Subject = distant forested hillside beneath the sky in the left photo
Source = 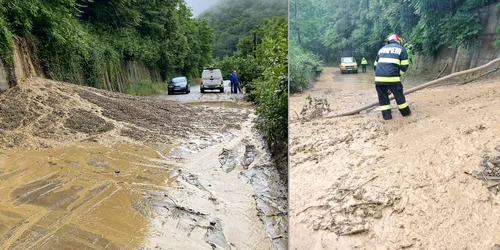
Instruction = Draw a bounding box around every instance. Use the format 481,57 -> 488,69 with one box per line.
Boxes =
199,0 -> 288,59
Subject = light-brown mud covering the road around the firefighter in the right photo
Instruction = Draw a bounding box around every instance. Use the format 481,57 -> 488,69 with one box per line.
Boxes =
289,68 -> 500,250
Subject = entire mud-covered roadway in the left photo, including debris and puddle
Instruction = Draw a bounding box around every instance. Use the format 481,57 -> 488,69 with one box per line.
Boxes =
0,78 -> 287,249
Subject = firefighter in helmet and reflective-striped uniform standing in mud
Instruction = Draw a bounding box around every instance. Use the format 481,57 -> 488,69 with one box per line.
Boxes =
373,34 -> 411,120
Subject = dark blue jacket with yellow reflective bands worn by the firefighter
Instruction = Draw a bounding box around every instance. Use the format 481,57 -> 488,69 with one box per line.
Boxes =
373,42 -> 409,85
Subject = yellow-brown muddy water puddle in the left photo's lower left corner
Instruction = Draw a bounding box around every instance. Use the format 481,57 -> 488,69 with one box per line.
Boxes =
0,144 -> 176,249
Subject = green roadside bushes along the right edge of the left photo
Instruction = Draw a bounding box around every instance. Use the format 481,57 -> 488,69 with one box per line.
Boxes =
215,16 -> 288,164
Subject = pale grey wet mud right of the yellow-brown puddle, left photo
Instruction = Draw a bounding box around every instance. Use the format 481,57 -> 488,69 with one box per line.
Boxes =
145,113 -> 288,250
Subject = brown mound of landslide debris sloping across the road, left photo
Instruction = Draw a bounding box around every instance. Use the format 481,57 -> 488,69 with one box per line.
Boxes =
0,78 -> 248,149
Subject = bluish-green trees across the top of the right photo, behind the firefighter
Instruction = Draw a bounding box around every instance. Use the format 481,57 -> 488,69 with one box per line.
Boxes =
290,0 -> 496,64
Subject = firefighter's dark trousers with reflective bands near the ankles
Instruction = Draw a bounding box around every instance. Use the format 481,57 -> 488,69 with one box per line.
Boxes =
375,82 -> 411,120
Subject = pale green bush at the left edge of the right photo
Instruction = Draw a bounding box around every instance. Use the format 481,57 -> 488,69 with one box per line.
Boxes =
290,41 -> 323,93
